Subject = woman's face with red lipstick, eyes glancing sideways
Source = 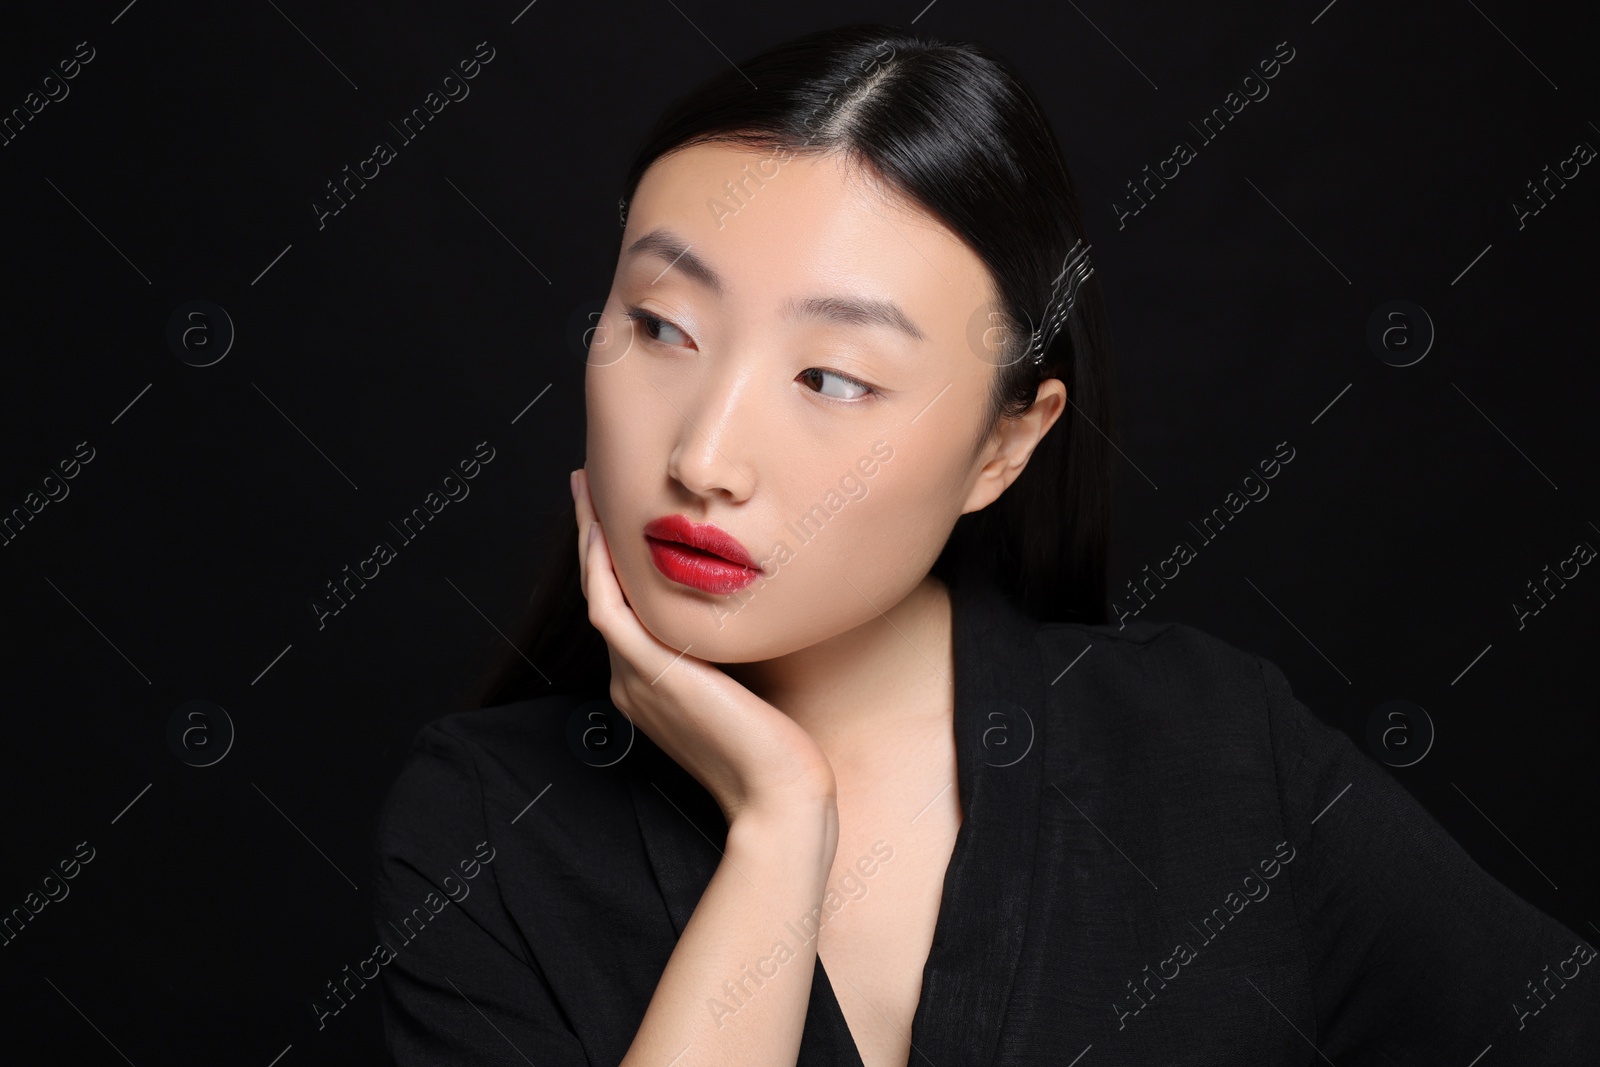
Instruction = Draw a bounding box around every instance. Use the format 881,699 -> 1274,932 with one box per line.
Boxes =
584,144 -> 1061,662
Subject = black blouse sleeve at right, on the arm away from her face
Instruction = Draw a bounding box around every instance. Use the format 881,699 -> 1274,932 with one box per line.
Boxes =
1258,659 -> 1600,1067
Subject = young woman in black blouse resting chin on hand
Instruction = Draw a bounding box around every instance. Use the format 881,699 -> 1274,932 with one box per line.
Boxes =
368,26 -> 1600,1067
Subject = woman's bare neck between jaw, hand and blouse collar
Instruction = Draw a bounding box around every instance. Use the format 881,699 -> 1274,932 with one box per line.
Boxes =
718,574 -> 955,769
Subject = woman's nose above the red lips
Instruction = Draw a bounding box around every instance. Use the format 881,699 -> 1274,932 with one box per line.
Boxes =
658,350 -> 762,502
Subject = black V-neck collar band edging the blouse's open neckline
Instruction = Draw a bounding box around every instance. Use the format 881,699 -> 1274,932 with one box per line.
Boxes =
629,563 -> 1045,1067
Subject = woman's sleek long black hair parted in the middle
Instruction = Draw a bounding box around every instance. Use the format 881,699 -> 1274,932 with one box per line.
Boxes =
470,24 -> 1117,707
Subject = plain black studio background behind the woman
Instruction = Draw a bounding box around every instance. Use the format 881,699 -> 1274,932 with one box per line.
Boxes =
0,0 -> 1600,1067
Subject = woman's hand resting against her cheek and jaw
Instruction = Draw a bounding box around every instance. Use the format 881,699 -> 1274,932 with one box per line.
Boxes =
573,467 -> 837,827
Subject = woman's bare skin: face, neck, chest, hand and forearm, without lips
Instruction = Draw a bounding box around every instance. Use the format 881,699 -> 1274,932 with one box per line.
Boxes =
573,144 -> 1066,1067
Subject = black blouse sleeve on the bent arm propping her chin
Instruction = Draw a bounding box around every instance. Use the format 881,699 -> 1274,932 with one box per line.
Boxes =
373,721 -> 589,1067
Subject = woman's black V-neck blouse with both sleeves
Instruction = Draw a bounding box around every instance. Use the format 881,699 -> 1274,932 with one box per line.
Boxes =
368,566 -> 1600,1067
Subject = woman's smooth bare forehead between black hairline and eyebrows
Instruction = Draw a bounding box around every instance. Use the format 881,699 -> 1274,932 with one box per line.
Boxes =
622,144 -> 990,313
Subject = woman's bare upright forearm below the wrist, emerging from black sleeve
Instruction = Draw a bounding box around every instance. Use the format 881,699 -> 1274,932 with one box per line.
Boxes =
622,800 -> 838,1067
